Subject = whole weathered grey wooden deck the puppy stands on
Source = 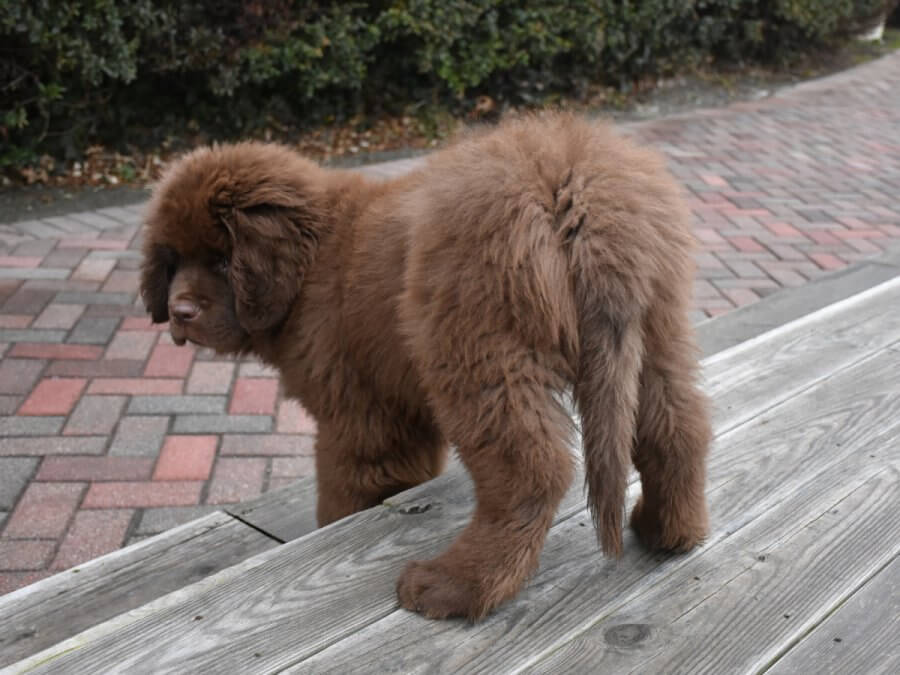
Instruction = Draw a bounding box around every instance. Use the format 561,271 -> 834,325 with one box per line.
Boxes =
0,277 -> 900,674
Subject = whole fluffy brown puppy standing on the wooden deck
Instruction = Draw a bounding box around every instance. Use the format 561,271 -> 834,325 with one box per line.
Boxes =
142,114 -> 710,619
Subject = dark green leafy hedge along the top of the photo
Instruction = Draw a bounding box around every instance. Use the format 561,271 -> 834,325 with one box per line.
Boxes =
0,0 -> 895,167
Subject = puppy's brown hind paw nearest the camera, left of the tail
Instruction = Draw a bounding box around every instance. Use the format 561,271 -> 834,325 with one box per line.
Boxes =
397,559 -> 490,621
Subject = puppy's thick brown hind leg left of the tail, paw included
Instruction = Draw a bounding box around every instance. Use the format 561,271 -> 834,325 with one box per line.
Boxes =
397,332 -> 573,620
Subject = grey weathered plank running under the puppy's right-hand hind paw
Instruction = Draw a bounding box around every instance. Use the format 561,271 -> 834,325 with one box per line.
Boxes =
286,350 -> 900,673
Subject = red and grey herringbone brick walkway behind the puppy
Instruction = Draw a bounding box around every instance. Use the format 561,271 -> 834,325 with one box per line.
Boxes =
0,52 -> 900,593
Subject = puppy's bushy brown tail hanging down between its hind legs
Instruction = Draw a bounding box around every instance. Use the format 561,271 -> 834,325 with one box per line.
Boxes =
573,251 -> 643,557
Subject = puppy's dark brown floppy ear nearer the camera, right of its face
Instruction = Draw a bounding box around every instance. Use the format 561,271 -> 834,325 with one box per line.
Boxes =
222,203 -> 318,333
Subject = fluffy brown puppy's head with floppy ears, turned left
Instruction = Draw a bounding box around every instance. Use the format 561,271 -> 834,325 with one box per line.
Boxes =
141,143 -> 324,353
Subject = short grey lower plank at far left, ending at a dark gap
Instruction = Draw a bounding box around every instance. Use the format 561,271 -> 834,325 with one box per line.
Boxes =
0,512 -> 278,666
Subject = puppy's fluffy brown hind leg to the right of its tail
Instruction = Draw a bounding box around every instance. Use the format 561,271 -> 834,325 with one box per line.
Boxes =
631,298 -> 711,551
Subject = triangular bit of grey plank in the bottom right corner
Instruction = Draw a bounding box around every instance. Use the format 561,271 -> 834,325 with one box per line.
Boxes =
766,558 -> 900,675
